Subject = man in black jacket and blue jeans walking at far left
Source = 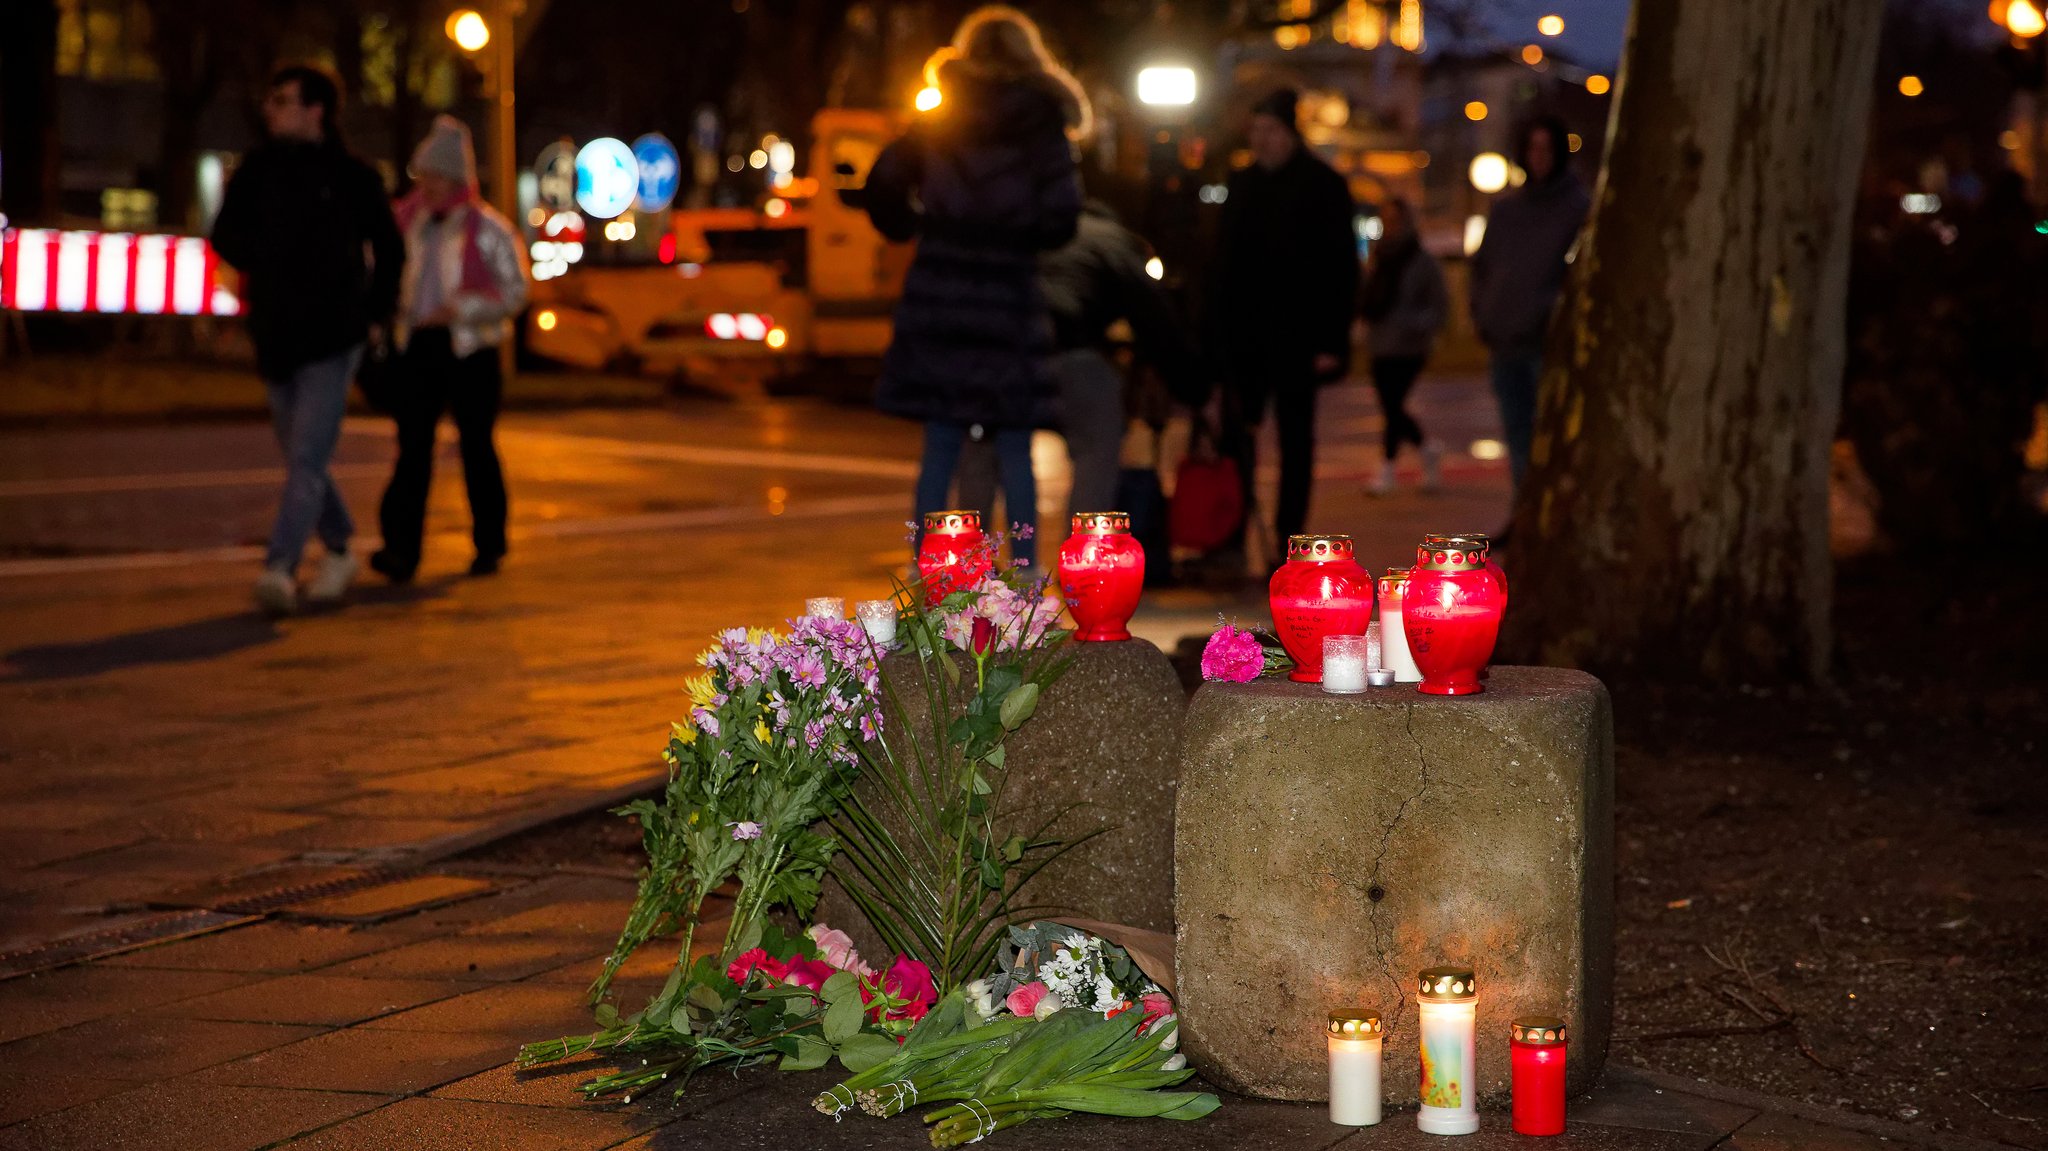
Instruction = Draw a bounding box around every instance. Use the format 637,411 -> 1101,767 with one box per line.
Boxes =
213,66 -> 406,614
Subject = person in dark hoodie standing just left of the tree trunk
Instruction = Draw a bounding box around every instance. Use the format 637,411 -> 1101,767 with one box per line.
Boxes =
1470,117 -> 1591,497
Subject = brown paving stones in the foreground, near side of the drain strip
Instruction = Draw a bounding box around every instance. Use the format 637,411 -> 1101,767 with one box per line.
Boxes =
0,862 -> 1989,1151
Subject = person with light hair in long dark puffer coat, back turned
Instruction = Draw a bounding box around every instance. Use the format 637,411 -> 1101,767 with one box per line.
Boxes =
864,4 -> 1090,565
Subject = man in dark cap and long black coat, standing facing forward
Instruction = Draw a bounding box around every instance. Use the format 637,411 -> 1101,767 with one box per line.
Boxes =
1208,88 -> 1358,559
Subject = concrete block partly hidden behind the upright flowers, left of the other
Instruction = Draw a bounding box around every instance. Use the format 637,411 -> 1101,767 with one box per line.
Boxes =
817,639 -> 1188,956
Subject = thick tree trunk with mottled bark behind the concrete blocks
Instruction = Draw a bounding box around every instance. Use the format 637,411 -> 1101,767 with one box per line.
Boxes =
1503,0 -> 1884,682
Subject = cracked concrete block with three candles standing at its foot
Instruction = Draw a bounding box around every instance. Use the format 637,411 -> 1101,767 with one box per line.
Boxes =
1174,668 -> 1614,1104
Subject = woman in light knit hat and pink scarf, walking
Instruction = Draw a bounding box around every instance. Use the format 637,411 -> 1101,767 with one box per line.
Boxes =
371,117 -> 526,584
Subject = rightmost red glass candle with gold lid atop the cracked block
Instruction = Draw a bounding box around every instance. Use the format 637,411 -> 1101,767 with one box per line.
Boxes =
1401,541 -> 1501,696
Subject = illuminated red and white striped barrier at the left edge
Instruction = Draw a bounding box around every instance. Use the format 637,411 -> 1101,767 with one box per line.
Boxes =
0,227 -> 242,315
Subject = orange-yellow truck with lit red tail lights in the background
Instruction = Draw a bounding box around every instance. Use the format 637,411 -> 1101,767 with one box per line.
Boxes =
524,109 -> 909,389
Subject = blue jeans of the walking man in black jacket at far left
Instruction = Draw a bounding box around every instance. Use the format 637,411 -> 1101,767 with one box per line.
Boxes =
262,344 -> 362,571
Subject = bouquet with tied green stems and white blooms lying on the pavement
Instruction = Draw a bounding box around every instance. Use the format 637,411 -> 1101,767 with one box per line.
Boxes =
813,924 -> 1219,1147
